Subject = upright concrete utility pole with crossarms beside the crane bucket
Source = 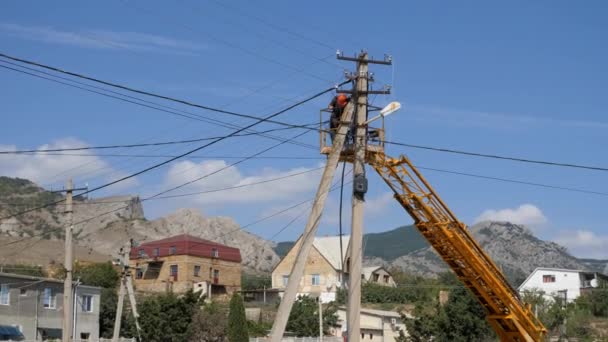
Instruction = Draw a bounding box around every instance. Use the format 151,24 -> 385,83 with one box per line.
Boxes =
346,52 -> 368,342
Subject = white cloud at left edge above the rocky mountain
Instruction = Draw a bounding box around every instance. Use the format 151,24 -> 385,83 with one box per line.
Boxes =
0,138 -> 137,190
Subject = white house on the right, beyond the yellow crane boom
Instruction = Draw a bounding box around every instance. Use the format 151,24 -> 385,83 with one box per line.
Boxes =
518,267 -> 608,302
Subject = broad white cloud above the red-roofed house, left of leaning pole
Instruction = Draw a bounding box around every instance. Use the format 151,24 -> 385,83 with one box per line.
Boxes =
165,160 -> 321,205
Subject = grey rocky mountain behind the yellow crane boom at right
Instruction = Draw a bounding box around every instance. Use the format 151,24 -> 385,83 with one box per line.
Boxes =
277,222 -> 608,285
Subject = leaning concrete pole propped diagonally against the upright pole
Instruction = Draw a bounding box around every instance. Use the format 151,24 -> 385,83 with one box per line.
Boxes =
270,103 -> 354,342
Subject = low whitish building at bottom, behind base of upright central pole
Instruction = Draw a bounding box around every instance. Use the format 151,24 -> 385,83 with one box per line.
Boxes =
332,308 -> 408,342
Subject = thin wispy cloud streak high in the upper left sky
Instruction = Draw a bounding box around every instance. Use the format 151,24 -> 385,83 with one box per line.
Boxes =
0,23 -> 204,54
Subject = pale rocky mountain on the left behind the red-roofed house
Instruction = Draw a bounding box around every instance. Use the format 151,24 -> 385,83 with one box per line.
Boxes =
0,177 -> 279,272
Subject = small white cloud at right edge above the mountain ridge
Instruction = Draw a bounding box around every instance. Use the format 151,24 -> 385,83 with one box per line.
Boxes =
554,229 -> 608,259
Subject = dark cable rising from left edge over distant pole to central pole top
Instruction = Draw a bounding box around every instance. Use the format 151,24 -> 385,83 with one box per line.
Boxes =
0,81 -> 334,220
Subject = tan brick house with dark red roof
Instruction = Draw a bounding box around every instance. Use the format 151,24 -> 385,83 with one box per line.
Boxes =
129,234 -> 241,296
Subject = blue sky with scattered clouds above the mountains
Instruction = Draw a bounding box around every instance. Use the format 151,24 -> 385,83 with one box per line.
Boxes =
0,0 -> 608,258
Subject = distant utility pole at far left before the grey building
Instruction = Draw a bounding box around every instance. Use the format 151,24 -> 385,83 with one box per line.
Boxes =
61,178 -> 74,342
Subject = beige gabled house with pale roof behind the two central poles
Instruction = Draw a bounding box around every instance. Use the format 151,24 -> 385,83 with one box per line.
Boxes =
272,235 -> 395,303
